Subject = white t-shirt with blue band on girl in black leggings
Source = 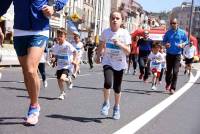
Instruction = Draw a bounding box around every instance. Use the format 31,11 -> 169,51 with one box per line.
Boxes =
100,28 -> 131,71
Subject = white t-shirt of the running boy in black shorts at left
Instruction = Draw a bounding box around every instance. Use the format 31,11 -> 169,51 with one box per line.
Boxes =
52,41 -> 76,71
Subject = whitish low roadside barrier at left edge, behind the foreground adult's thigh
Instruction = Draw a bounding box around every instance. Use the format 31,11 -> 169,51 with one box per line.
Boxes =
0,44 -> 19,66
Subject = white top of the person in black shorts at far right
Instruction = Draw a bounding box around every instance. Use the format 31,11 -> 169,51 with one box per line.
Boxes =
183,45 -> 196,59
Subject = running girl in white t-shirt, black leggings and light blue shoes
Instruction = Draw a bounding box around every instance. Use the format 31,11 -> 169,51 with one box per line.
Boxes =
96,11 -> 131,120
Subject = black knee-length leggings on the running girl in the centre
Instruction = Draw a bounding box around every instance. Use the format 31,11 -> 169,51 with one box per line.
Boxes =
103,65 -> 123,94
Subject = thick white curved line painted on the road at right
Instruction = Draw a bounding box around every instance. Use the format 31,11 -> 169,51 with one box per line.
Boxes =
114,70 -> 200,134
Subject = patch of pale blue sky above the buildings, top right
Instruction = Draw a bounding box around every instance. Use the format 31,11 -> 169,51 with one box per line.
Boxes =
135,0 -> 200,12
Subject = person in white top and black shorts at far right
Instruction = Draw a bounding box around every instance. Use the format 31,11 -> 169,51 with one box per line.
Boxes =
183,42 -> 196,75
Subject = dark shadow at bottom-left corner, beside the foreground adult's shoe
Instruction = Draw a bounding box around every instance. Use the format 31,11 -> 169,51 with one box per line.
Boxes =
0,117 -> 25,125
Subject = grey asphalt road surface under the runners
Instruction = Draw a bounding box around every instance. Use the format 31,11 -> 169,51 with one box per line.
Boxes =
0,65 -> 200,134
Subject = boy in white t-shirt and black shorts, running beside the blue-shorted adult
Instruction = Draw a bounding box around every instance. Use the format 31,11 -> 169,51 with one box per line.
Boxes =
52,28 -> 77,100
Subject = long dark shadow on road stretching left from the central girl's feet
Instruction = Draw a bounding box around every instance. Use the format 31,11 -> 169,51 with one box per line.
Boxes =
46,114 -> 111,123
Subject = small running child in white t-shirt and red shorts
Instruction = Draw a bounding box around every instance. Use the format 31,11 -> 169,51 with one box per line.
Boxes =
148,42 -> 164,90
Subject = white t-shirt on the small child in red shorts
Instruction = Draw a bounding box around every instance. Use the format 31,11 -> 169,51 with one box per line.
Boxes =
148,52 -> 164,72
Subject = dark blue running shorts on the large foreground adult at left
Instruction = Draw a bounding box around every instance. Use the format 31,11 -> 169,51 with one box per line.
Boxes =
13,35 -> 48,56
